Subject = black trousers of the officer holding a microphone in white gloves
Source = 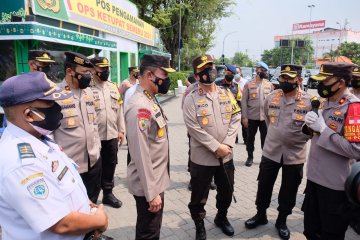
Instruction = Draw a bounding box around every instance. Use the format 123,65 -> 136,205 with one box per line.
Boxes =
302,180 -> 349,240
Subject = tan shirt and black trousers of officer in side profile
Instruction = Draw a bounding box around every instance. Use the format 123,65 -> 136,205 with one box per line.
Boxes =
124,85 -> 170,239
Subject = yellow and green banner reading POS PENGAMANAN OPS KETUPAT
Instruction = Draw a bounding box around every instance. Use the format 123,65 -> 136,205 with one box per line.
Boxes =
32,0 -> 157,46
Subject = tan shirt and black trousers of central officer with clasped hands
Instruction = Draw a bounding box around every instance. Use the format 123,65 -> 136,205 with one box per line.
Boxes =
183,86 -> 241,221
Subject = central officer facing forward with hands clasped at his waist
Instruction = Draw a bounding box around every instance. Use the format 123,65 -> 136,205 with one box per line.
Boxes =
183,54 -> 241,239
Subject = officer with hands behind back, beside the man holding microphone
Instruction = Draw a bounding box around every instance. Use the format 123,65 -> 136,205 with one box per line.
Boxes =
245,64 -> 311,239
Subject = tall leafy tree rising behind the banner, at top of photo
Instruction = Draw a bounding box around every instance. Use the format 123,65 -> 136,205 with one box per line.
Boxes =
133,0 -> 234,66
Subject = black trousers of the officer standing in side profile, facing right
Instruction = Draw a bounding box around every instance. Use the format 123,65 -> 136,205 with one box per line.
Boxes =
134,193 -> 164,240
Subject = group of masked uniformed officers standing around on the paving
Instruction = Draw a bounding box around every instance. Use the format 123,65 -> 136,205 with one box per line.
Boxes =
0,47 -> 360,239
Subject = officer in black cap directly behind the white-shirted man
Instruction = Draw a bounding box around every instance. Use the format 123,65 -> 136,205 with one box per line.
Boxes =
53,52 -> 101,203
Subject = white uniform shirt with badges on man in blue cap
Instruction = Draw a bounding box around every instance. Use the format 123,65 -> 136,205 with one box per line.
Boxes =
0,122 -> 90,240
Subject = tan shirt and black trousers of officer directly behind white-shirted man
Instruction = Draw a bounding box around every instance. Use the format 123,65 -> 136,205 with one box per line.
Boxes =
53,80 -> 101,202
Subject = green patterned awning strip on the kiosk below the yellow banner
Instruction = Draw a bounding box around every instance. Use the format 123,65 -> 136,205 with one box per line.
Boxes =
0,22 -> 117,51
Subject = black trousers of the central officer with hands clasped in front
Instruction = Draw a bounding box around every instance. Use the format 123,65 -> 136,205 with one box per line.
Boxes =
188,160 -> 235,221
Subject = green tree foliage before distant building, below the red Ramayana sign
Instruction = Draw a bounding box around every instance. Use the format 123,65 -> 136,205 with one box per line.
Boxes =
261,40 -> 314,67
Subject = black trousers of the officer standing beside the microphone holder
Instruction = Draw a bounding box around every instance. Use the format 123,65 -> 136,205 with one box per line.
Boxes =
256,156 -> 304,218
